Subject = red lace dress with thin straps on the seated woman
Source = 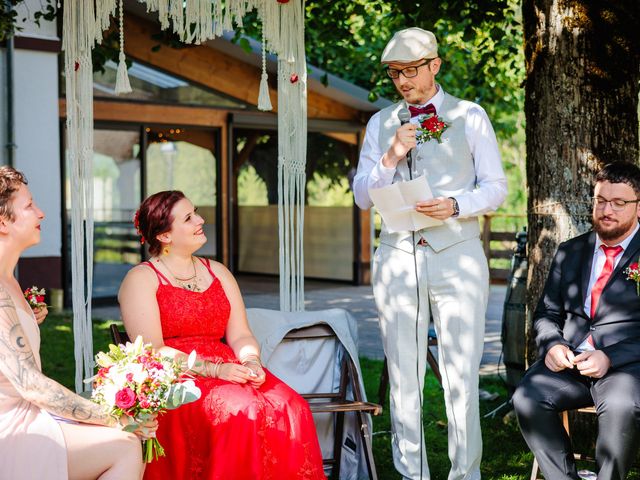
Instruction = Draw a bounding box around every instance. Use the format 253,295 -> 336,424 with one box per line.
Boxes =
144,262 -> 325,480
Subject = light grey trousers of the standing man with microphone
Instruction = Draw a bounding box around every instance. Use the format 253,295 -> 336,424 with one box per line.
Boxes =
373,238 -> 489,480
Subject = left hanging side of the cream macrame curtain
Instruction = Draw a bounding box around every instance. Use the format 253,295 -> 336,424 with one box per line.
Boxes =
62,0 -> 102,392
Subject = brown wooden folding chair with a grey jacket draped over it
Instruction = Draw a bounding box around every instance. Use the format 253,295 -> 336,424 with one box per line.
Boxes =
282,323 -> 382,480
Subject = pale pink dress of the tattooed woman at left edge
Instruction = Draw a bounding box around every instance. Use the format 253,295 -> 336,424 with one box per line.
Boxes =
0,308 -> 68,480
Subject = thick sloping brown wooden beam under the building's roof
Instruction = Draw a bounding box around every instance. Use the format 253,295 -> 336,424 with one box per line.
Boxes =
119,15 -> 360,121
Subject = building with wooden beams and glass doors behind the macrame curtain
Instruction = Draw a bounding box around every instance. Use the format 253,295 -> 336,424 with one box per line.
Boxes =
0,2 -> 388,301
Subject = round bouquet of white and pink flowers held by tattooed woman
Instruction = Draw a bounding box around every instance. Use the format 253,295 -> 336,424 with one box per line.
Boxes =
86,336 -> 200,463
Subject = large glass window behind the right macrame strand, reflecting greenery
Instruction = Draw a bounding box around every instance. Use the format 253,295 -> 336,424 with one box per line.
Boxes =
233,128 -> 357,281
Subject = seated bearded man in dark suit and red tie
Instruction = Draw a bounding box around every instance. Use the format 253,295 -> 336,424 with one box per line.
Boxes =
513,162 -> 640,480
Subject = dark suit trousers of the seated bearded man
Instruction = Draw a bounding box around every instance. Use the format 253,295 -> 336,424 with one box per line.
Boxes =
513,360 -> 640,480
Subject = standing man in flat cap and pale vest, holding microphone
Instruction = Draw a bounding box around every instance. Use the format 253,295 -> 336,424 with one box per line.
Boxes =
353,28 -> 507,480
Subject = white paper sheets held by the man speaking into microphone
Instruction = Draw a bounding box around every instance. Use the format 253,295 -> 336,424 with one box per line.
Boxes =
369,176 -> 442,233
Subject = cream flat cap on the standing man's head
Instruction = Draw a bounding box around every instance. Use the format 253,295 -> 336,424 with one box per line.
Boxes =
380,27 -> 438,63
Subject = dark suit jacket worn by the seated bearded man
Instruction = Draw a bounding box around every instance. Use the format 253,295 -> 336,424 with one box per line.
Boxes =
534,230 -> 640,368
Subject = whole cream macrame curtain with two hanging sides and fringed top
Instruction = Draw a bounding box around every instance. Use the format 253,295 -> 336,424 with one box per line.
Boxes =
62,0 -> 307,391
